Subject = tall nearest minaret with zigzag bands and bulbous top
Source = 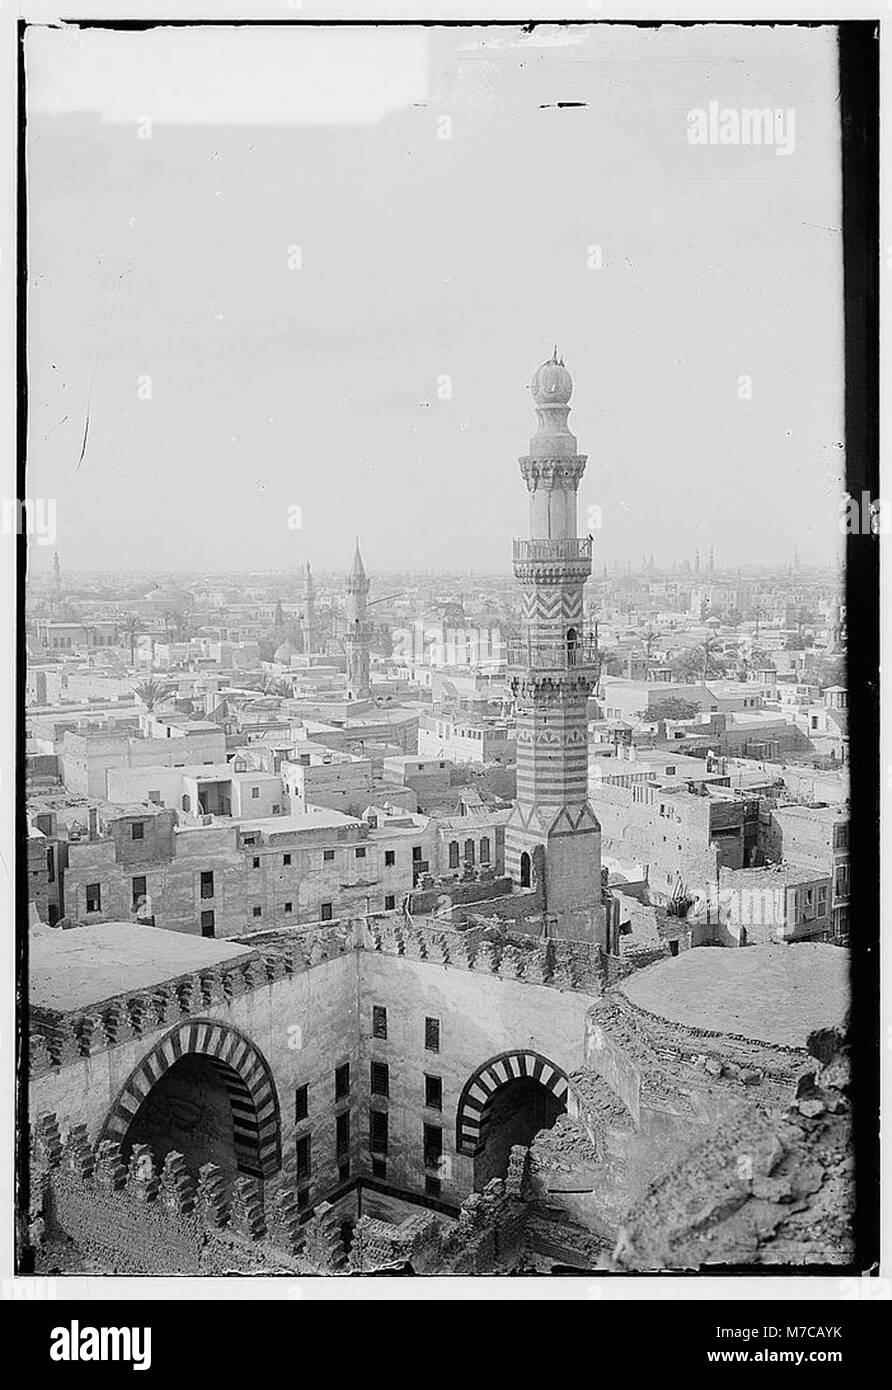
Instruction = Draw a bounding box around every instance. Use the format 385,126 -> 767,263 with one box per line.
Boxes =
504,349 -> 606,945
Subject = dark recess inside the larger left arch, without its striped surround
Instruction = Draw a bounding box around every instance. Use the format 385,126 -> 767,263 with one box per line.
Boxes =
121,1054 -> 239,1177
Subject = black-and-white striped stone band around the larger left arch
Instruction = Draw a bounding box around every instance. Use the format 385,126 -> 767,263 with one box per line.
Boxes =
103,1019 -> 282,1177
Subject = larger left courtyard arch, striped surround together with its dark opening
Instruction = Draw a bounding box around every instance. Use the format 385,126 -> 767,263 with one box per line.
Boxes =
103,1019 -> 282,1177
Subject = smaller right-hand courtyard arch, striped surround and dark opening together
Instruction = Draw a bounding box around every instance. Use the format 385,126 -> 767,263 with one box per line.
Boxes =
456,1051 -> 567,1191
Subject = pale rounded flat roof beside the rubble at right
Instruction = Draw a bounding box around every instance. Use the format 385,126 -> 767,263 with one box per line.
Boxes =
618,941 -> 849,1049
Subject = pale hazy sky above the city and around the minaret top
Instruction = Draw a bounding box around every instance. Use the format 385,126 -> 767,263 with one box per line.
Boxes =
26,25 -> 845,571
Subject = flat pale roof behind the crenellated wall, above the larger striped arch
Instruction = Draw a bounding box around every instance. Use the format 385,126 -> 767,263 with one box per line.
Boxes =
28,922 -> 253,1013
